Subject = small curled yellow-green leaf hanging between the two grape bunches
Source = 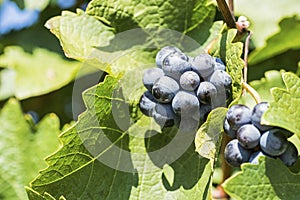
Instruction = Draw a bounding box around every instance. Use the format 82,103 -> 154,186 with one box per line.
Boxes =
195,107 -> 227,160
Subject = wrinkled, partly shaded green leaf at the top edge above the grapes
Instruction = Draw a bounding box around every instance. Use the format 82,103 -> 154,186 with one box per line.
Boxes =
86,0 -> 215,43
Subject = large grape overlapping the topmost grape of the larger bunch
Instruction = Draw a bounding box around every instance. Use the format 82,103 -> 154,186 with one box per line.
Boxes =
162,53 -> 192,81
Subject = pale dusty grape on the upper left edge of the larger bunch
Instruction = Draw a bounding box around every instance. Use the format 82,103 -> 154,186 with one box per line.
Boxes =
142,67 -> 164,91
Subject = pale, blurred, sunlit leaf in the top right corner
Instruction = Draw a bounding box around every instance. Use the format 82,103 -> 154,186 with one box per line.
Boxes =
234,0 -> 300,48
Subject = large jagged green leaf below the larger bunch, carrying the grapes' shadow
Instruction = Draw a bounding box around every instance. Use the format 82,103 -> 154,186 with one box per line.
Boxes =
27,76 -> 212,199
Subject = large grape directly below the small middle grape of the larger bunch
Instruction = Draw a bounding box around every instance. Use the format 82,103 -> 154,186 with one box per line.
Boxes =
172,91 -> 200,119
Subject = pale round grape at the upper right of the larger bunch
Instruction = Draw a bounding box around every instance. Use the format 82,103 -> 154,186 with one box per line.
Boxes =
190,53 -> 215,78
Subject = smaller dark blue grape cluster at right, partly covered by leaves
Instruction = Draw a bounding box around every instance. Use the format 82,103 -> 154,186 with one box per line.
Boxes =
224,102 -> 298,167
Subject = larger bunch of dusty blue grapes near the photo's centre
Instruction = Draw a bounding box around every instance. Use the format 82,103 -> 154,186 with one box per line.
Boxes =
139,46 -> 232,131
